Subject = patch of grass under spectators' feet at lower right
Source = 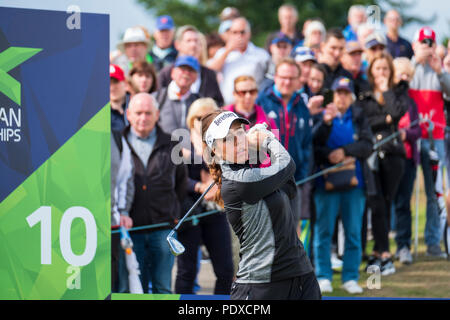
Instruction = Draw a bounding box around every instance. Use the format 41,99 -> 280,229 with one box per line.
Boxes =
324,172 -> 450,298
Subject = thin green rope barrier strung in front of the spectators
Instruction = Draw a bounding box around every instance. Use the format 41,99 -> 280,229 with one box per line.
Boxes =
111,119 -> 450,233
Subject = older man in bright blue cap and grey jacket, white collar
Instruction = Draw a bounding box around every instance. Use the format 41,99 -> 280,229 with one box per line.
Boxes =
155,56 -> 200,149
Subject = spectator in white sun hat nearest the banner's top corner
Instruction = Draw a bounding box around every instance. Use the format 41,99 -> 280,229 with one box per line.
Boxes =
111,26 -> 153,74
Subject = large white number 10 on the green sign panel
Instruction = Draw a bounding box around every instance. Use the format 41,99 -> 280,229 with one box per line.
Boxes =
26,206 -> 97,267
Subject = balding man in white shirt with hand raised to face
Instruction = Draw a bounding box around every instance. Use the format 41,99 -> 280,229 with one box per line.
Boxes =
208,17 -> 270,104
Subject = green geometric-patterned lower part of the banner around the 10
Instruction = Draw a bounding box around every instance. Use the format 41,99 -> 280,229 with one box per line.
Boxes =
0,103 -> 111,299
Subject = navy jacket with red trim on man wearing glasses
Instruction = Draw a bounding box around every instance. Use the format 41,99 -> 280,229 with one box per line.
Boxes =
256,86 -> 312,181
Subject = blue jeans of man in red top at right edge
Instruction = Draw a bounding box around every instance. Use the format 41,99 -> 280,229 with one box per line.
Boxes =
420,139 -> 445,246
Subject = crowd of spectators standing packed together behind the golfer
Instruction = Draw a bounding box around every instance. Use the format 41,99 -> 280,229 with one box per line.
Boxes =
110,5 -> 450,294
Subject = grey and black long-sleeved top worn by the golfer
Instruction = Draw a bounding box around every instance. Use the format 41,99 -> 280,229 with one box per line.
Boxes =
221,138 -> 313,283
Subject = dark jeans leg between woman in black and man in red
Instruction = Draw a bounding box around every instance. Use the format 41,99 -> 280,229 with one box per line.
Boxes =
394,159 -> 417,251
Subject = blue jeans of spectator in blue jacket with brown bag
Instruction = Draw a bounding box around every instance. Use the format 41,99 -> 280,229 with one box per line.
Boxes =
313,188 -> 366,282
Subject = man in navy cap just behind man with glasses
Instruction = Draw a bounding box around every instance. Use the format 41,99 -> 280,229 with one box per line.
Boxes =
259,32 -> 292,91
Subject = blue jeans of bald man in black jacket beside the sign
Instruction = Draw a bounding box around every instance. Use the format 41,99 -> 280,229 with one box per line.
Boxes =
131,229 -> 175,294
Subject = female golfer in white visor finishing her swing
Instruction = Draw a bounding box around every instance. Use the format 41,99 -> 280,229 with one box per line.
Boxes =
202,111 -> 321,300
